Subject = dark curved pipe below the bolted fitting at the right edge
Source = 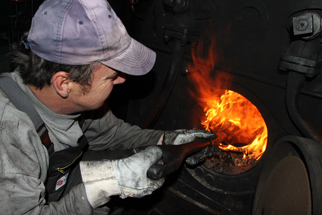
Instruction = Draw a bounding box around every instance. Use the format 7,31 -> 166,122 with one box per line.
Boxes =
286,72 -> 322,145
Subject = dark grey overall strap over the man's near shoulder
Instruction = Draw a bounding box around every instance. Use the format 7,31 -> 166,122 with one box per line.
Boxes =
0,76 -> 54,155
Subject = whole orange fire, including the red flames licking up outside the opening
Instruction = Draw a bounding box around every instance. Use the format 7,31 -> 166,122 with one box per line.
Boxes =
189,34 -> 268,163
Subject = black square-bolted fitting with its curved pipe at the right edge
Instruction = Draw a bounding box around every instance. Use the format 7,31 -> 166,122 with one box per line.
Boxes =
279,11 -> 322,144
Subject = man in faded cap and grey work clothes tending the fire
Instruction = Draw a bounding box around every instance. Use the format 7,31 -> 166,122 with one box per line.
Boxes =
0,0 -> 215,214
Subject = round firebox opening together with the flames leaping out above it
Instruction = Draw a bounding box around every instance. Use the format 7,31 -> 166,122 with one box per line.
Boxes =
188,26 -> 268,174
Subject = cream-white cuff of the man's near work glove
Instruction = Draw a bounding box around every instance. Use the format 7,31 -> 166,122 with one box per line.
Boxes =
80,160 -> 120,209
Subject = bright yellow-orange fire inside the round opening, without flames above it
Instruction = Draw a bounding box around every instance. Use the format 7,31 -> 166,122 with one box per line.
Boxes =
201,90 -> 267,159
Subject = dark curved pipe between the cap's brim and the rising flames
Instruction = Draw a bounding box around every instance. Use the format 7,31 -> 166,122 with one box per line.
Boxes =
141,40 -> 186,128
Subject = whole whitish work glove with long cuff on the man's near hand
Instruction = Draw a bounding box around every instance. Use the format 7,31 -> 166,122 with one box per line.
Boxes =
80,146 -> 164,209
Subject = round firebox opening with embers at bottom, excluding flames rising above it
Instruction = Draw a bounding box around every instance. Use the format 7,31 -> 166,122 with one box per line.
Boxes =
190,90 -> 268,175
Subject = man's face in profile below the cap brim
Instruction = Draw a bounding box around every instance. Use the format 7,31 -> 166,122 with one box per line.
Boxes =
70,65 -> 125,112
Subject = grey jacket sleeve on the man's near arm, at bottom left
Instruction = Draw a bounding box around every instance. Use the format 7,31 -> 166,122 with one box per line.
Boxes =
0,97 -> 93,214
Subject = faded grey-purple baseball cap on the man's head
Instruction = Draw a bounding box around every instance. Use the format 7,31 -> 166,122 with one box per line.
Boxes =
28,0 -> 156,75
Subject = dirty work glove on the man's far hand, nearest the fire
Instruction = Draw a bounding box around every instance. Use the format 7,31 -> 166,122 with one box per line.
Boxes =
162,129 -> 217,166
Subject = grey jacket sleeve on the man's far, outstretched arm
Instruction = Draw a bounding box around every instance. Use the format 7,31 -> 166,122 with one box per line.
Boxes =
83,105 -> 163,150
